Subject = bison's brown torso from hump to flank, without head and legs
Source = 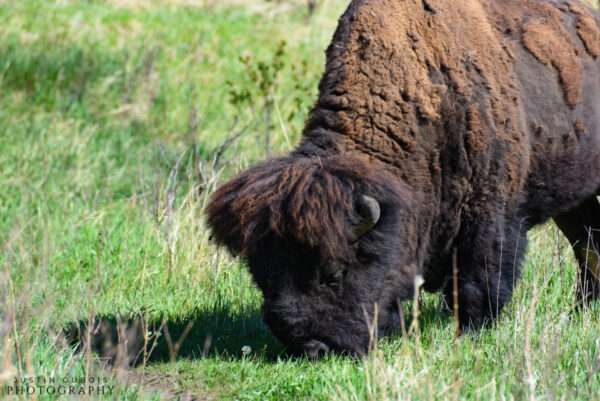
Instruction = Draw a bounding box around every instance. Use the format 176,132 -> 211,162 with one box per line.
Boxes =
296,0 -> 600,288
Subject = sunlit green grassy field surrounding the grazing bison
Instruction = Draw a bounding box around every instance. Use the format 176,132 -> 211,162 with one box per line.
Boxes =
0,0 -> 600,401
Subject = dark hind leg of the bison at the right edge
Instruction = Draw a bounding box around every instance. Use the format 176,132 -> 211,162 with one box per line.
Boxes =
554,196 -> 600,305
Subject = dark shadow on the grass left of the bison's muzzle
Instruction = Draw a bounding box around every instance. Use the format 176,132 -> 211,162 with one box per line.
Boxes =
65,308 -> 289,367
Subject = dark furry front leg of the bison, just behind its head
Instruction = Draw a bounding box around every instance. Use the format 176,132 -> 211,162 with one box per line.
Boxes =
444,214 -> 527,329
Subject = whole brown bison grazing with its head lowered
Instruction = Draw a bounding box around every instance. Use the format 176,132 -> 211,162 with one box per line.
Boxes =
207,0 -> 600,356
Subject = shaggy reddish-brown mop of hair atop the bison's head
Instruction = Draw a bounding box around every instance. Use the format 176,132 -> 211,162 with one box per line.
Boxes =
207,155 -> 401,260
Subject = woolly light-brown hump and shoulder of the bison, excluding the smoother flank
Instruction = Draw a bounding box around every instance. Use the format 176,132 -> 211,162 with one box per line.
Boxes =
297,0 -> 528,276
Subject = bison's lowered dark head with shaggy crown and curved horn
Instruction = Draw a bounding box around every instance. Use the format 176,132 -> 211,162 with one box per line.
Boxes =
208,156 -> 416,357
